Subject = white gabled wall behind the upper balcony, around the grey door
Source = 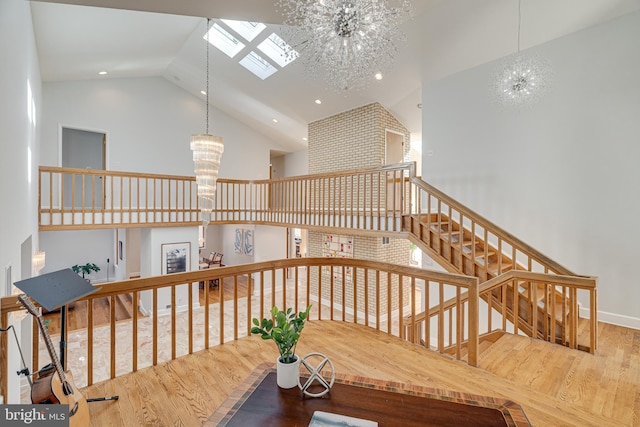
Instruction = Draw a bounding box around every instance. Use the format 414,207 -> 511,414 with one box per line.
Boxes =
41,77 -> 280,179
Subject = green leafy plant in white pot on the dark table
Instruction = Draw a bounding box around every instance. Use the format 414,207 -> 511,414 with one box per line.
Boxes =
251,306 -> 311,388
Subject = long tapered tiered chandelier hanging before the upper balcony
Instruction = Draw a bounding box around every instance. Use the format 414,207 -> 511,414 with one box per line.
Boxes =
191,19 -> 224,227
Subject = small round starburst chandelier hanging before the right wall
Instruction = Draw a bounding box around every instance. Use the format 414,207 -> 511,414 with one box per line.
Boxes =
495,0 -> 549,107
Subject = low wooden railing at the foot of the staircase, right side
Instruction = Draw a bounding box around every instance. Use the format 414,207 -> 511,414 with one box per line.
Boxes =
404,270 -> 598,359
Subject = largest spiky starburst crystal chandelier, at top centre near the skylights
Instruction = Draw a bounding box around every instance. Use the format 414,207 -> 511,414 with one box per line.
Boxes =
277,0 -> 411,91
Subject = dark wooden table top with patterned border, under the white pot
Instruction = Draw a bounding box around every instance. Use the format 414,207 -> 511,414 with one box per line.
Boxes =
203,364 -> 531,427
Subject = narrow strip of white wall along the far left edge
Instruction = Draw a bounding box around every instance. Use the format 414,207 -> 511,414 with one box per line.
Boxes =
0,0 -> 41,403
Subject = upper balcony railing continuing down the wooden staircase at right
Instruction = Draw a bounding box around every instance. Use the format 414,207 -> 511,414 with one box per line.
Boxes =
39,163 -> 597,368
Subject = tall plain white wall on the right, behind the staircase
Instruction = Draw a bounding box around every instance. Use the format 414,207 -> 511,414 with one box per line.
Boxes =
422,13 -> 640,327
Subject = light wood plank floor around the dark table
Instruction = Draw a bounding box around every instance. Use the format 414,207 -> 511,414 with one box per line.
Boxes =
83,320 -> 640,427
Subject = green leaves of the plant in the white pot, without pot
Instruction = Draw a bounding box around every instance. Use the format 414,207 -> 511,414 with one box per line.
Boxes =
251,306 -> 311,363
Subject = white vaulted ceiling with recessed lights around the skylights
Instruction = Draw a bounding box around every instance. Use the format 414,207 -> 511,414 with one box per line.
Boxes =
31,0 -> 640,152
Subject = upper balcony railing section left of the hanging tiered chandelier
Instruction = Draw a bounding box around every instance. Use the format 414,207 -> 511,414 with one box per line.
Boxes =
38,166 -> 199,231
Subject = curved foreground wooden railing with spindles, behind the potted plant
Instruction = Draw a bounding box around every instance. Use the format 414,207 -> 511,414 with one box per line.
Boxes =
0,258 -> 479,399
